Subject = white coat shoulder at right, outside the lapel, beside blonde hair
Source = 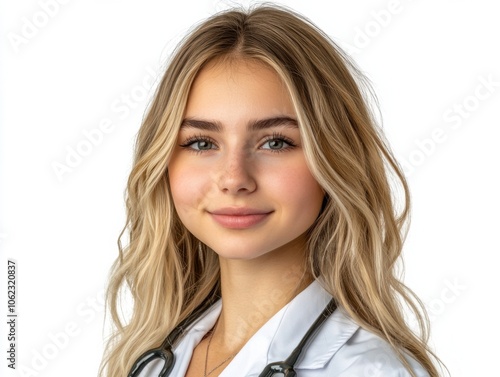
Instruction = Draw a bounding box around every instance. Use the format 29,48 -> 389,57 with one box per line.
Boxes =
330,320 -> 429,377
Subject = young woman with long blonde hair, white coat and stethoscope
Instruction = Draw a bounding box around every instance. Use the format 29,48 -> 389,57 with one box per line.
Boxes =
101,6 -> 444,377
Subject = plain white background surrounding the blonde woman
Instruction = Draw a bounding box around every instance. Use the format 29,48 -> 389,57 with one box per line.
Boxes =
0,0 -> 500,377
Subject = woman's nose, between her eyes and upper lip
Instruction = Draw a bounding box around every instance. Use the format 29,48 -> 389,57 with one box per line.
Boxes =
217,152 -> 257,195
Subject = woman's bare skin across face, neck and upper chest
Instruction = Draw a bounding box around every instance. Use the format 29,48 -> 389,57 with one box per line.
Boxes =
168,60 -> 324,377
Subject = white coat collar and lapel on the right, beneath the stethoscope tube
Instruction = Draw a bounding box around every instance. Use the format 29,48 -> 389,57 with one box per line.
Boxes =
220,281 -> 359,377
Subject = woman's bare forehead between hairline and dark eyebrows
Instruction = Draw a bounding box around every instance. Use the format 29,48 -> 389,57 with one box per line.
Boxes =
185,59 -> 295,121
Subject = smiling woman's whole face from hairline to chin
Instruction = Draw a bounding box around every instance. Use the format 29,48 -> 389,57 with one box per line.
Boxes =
168,60 -> 323,259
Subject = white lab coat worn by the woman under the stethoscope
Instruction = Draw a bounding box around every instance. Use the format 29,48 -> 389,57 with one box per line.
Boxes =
141,281 -> 429,377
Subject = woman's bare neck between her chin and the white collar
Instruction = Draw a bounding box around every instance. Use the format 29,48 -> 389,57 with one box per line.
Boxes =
214,238 -> 312,352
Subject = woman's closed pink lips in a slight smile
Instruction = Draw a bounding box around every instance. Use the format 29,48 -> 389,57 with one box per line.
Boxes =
208,207 -> 273,229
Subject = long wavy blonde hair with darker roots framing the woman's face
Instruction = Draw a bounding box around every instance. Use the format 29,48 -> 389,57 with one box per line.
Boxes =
100,5 -> 444,377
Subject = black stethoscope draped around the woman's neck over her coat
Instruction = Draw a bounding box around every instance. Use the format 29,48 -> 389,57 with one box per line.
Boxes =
128,299 -> 337,377
